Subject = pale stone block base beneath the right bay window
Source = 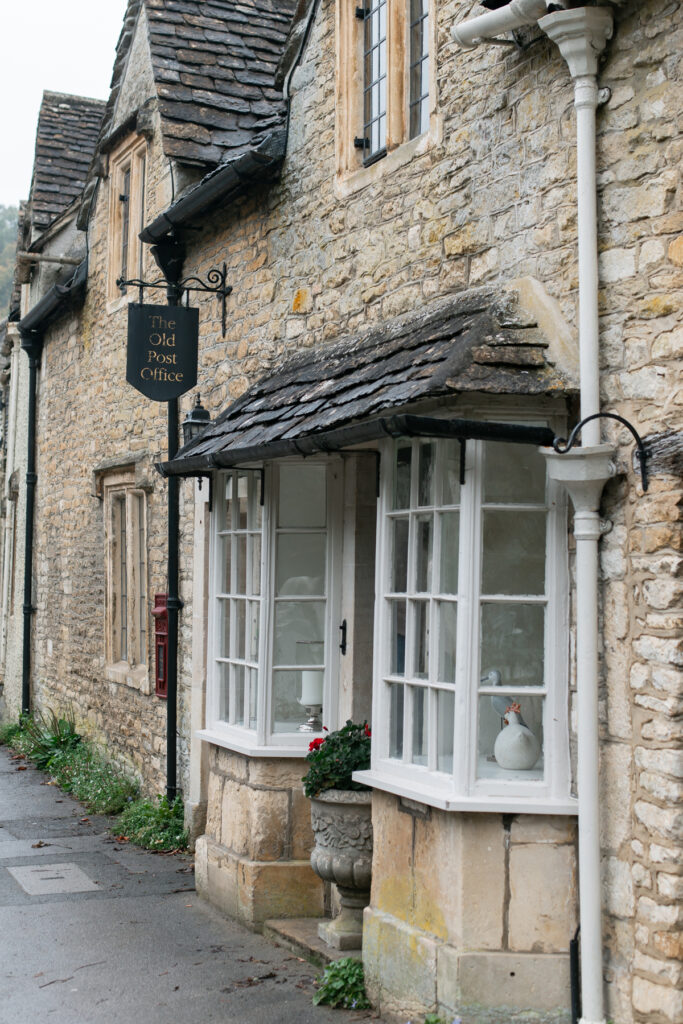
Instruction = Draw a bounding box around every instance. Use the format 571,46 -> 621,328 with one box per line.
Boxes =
362,793 -> 578,1024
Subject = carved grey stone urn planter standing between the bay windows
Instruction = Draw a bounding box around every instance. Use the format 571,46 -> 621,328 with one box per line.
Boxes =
310,790 -> 373,949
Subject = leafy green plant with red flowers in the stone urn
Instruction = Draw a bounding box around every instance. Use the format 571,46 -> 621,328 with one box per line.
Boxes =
301,720 -> 371,797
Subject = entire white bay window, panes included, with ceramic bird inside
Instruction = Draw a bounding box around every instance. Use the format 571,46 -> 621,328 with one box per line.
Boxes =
359,439 -> 573,813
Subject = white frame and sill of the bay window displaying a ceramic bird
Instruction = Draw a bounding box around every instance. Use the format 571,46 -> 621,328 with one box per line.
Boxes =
354,418 -> 577,814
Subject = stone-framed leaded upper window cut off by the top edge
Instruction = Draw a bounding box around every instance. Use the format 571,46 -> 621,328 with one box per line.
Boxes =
337,0 -> 435,186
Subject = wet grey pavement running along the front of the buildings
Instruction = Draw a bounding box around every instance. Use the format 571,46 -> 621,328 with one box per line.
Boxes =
0,748 -> 372,1024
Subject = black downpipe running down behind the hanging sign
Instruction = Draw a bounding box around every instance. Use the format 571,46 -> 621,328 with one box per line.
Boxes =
152,240 -> 184,803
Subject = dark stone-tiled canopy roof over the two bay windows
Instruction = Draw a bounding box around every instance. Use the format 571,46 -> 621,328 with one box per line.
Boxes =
158,289 -> 577,476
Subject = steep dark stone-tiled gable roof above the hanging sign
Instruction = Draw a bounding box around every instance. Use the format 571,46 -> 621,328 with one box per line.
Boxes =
102,0 -> 296,167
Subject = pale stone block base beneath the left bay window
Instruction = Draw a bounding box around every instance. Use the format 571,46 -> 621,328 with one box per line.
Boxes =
195,745 -> 325,929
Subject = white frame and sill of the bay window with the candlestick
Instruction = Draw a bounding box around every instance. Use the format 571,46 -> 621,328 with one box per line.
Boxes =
199,457 -> 343,758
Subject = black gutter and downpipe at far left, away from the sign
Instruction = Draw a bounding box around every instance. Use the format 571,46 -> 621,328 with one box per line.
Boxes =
17,259 -> 88,715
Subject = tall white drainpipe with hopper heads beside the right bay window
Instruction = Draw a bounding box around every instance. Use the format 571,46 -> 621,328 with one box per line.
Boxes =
452,8 -> 614,1024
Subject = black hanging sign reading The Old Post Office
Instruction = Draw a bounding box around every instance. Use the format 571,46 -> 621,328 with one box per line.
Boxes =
126,302 -> 199,401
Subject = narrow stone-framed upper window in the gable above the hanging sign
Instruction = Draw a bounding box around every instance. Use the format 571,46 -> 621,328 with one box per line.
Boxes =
109,136 -> 147,299
